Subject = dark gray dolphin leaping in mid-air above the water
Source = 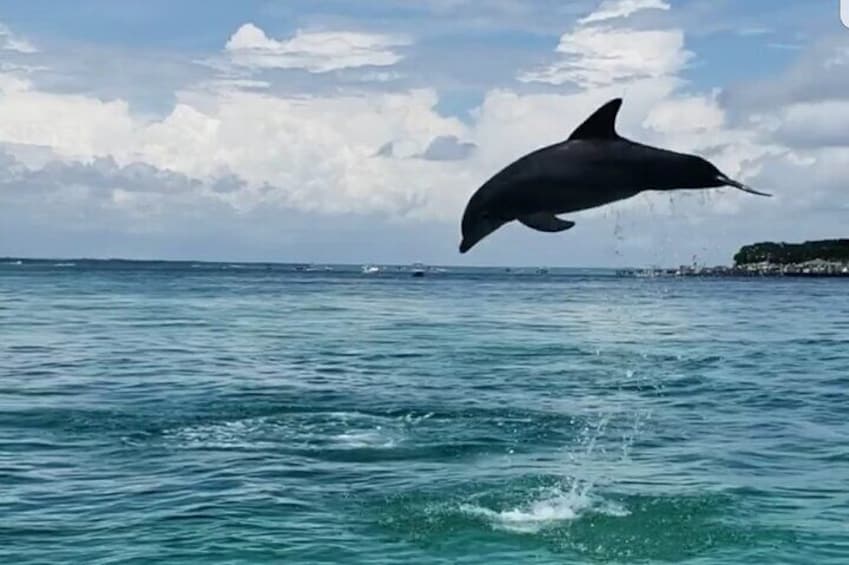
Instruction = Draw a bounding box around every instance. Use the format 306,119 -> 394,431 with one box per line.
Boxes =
460,98 -> 770,253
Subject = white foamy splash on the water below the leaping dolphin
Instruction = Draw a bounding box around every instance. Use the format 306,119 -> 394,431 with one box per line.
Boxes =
460,488 -> 630,534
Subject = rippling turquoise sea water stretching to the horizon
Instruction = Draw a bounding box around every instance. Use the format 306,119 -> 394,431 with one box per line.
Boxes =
0,261 -> 849,564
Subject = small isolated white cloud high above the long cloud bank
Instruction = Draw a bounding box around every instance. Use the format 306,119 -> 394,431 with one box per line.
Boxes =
225,23 -> 410,73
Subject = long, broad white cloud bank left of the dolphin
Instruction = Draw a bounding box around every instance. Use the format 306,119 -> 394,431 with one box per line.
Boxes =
0,72 -> 475,225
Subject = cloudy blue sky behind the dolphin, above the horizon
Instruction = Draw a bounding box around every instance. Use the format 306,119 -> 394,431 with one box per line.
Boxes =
0,0 -> 849,267
